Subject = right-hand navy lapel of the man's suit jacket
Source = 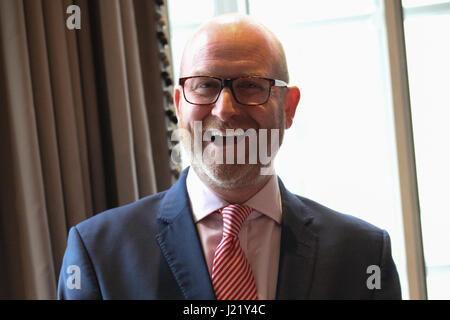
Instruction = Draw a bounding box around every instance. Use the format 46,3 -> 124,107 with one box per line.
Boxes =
276,180 -> 317,300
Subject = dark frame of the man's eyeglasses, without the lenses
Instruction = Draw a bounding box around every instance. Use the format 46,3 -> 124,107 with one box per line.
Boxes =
178,76 -> 288,106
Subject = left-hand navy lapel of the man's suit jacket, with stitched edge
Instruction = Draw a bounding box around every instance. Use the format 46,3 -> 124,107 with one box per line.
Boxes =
156,169 -> 216,299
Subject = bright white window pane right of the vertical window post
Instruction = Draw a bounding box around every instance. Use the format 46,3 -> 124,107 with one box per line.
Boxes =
403,0 -> 450,299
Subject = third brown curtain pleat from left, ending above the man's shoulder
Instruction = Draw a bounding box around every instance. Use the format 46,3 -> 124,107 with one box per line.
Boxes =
42,0 -> 88,225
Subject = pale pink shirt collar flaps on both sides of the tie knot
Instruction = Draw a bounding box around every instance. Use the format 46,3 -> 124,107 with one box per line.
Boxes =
186,168 -> 281,223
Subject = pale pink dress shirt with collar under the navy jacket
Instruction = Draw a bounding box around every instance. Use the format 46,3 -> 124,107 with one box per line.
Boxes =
186,168 -> 281,300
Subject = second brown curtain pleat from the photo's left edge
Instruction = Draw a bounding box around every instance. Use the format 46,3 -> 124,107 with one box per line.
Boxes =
24,0 -> 67,284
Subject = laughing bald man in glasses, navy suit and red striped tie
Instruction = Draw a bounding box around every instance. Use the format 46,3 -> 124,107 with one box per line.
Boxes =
58,15 -> 401,299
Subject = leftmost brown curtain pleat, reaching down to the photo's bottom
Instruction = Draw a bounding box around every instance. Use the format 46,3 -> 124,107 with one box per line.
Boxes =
0,0 -> 56,299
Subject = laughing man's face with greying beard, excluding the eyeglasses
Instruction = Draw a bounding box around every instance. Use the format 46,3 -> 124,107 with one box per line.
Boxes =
174,25 -> 296,189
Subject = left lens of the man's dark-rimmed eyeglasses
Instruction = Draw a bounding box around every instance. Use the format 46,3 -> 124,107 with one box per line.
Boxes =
184,77 -> 221,104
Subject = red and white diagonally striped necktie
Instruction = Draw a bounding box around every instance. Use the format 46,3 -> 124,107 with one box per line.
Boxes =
211,204 -> 258,300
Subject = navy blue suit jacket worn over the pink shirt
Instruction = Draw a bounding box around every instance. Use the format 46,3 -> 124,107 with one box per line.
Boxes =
58,170 -> 401,299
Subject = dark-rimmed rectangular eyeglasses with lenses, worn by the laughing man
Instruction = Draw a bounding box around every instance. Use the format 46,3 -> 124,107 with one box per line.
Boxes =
179,76 -> 288,106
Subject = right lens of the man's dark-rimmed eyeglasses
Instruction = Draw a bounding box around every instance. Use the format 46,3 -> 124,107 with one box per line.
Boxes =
233,77 -> 270,105
